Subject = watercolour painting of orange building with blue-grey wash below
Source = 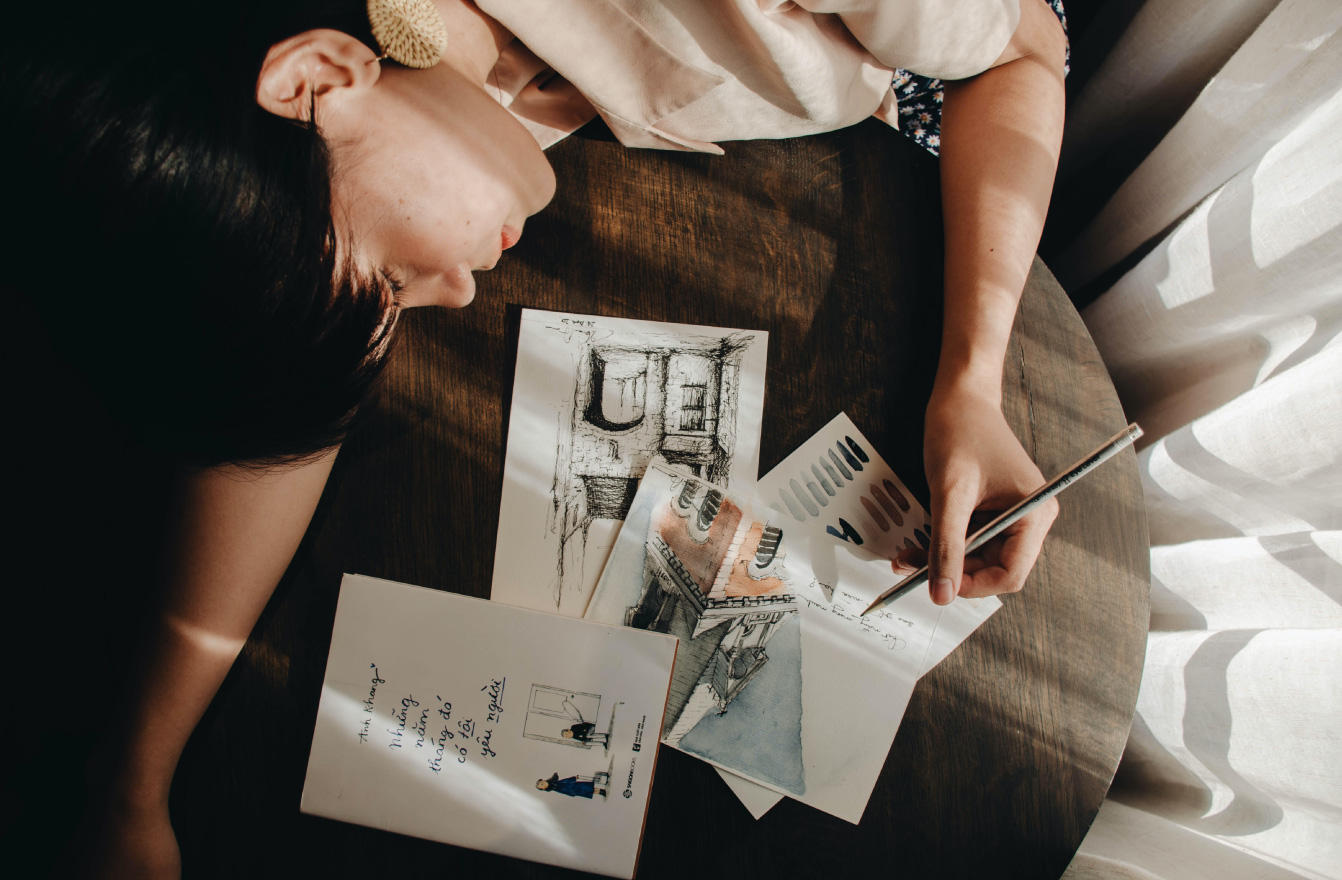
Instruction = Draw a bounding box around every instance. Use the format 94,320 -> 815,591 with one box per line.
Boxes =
609,471 -> 805,793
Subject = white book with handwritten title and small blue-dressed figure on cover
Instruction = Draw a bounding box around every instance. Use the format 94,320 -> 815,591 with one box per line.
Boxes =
302,574 -> 676,877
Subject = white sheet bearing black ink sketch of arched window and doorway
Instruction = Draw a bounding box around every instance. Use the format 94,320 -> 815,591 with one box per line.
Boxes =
491,310 -> 769,617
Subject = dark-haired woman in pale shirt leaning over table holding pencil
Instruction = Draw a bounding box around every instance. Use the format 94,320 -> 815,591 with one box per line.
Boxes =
3,0 -> 1066,877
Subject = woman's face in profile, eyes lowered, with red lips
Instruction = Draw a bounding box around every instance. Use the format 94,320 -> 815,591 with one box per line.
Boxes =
318,64 -> 554,307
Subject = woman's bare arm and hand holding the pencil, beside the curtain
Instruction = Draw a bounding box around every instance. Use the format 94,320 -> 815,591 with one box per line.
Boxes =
923,0 -> 1066,604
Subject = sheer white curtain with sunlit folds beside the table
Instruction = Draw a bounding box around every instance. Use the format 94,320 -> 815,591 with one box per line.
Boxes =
1053,0 -> 1342,880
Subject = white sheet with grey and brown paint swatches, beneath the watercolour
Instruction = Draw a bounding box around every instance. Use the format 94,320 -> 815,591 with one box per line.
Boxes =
718,413 -> 1001,818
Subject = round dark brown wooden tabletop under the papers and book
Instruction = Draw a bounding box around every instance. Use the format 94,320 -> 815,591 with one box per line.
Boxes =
5,123 -> 1149,879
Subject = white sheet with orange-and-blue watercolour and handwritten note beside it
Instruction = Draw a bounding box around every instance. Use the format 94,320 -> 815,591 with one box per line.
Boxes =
588,463 -> 941,822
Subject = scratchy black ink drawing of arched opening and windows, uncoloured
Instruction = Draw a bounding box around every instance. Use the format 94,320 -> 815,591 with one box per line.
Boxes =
549,322 -> 756,606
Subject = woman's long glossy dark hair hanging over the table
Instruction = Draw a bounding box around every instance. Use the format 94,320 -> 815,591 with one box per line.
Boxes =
0,3 -> 391,464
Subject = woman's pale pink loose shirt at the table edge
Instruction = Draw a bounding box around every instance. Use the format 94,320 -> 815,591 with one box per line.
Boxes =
478,0 -> 1020,153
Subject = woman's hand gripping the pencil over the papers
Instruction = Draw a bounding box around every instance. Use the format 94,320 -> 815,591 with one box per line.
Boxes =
895,389 -> 1057,605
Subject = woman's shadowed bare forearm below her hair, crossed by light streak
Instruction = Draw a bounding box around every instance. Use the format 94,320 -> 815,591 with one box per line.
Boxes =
94,451 -> 336,877
